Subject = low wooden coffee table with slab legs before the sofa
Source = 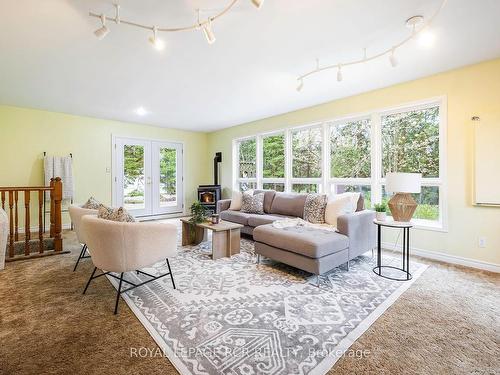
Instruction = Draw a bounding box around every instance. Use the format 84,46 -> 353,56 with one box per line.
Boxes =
181,218 -> 243,259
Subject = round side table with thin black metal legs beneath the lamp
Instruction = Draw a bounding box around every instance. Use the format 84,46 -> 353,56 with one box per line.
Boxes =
373,220 -> 413,281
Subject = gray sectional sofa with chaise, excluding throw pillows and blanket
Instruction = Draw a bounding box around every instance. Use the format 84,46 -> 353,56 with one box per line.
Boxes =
217,190 -> 376,285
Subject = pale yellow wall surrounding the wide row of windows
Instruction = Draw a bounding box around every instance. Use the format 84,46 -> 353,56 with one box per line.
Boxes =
208,59 -> 500,264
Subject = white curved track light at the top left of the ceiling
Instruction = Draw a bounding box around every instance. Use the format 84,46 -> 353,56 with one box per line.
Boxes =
89,0 -> 264,50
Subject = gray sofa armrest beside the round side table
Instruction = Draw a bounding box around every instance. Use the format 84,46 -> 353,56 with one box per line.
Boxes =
337,210 -> 377,259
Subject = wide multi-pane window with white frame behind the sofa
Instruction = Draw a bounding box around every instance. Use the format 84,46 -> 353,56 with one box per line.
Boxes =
233,100 -> 446,228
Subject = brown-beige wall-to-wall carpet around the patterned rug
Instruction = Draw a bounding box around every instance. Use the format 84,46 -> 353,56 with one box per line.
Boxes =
0,229 -> 500,374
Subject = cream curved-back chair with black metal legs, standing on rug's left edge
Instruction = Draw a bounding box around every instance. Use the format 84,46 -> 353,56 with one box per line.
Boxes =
81,216 -> 177,314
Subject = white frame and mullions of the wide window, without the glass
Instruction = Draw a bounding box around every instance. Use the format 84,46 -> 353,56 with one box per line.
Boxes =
232,96 -> 448,232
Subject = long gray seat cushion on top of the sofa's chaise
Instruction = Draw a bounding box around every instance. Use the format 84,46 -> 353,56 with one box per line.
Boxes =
253,224 -> 349,258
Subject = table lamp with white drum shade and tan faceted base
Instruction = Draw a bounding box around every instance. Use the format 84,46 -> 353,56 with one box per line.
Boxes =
385,172 -> 422,222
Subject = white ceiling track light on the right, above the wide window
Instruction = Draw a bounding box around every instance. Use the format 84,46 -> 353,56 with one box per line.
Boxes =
294,0 -> 448,91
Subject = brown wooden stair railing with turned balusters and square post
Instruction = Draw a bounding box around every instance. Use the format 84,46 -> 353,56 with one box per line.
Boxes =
0,177 -> 66,261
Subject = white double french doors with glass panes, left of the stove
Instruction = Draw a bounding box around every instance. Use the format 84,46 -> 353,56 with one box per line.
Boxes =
113,137 -> 184,216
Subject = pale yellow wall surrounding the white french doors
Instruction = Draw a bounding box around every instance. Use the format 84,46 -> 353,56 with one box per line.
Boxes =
0,106 -> 211,222
